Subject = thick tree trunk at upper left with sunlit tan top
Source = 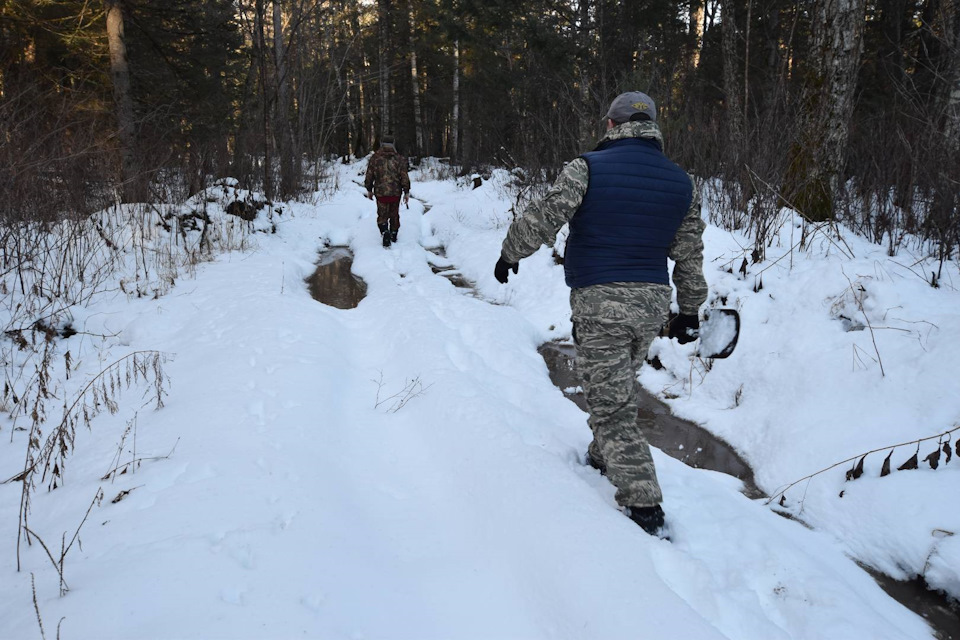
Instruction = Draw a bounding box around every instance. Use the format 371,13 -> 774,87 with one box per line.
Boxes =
104,0 -> 147,202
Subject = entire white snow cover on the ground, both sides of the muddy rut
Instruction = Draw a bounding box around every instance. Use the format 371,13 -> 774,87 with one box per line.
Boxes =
0,156 -> 960,640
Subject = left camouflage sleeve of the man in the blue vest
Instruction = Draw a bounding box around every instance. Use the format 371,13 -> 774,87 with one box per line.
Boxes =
500,158 -> 590,263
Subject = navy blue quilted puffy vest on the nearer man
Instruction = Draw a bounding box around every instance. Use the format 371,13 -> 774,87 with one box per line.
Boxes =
564,138 -> 693,289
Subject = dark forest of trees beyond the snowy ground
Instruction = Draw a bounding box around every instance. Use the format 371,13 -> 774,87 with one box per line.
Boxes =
0,0 -> 960,260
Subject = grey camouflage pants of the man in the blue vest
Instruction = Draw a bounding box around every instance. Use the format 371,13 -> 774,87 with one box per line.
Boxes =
570,283 -> 670,507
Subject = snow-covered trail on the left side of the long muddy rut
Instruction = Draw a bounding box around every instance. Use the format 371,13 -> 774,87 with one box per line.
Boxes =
0,166 -> 929,640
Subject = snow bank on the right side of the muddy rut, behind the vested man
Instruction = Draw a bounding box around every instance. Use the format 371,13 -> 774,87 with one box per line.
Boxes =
418,165 -> 960,598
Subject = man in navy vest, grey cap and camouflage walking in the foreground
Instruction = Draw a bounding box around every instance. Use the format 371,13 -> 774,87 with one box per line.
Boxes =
494,91 -> 707,535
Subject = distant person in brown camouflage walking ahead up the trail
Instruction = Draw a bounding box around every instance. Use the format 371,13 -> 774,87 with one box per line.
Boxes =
363,136 -> 410,247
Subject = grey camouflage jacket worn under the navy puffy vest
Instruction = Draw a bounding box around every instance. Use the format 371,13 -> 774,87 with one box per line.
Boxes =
501,121 -> 707,315
